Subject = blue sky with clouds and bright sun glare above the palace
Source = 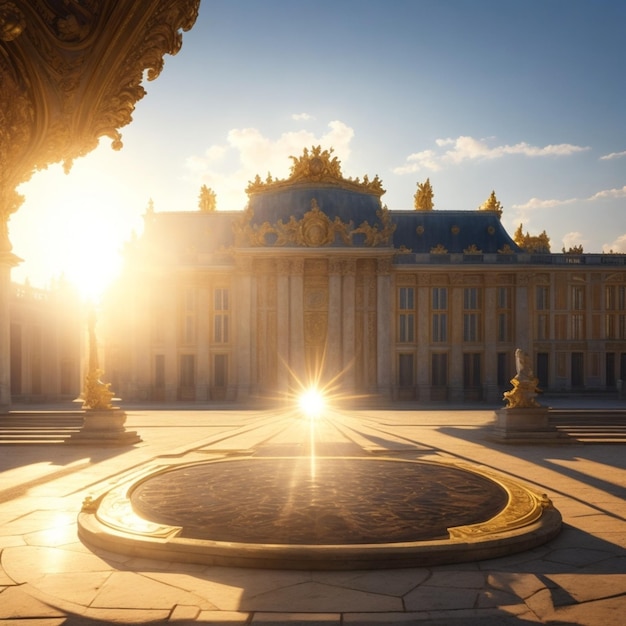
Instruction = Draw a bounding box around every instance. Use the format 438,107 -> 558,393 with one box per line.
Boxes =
9,0 -> 626,294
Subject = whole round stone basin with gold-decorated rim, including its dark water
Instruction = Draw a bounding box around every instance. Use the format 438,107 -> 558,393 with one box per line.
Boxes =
78,457 -> 561,570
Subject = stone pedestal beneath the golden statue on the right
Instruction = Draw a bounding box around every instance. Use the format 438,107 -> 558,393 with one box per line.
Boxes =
490,406 -> 568,443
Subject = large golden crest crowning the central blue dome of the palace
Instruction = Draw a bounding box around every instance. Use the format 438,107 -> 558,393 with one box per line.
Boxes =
246,146 -> 385,196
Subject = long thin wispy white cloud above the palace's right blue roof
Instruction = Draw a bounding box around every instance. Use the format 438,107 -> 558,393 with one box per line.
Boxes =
393,135 -> 589,174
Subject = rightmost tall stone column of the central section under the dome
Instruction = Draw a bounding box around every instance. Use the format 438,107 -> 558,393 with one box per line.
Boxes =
376,257 -> 394,398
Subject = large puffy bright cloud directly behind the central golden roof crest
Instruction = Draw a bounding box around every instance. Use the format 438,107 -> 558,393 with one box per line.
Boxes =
185,120 -> 354,210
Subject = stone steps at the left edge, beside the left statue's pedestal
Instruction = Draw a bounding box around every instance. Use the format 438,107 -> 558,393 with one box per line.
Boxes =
0,411 -> 83,445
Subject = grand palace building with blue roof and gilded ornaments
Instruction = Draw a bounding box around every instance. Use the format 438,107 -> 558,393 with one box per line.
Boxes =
100,147 -> 626,402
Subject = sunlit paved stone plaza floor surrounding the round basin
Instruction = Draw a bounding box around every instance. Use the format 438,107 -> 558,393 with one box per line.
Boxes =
0,406 -> 626,626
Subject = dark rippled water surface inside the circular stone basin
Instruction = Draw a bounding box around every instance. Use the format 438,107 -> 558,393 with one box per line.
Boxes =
130,457 -> 509,545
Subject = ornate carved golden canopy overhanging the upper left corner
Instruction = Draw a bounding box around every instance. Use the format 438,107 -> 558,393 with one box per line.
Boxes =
0,0 -> 200,253
